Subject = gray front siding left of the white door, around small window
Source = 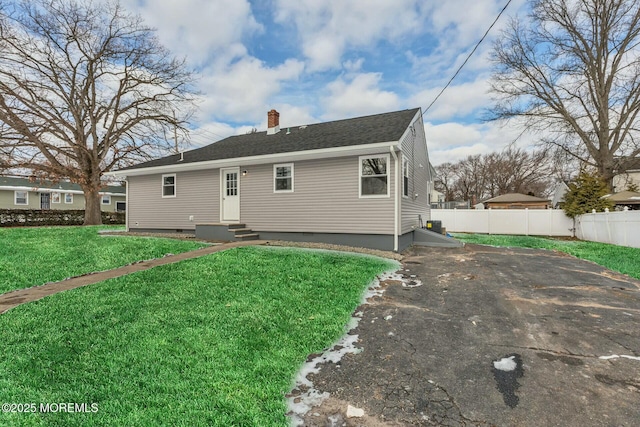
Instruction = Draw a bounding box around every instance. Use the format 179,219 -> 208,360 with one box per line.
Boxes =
127,169 -> 220,230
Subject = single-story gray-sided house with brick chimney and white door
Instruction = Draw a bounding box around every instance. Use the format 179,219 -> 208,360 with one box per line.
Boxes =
110,108 -> 460,251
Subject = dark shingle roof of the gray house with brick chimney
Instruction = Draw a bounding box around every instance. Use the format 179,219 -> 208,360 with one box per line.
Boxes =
121,108 -> 419,170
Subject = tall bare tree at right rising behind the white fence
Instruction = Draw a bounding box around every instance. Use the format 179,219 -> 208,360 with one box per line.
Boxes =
492,0 -> 640,188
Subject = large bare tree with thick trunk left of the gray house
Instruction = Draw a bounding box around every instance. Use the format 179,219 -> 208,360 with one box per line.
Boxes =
0,0 -> 194,224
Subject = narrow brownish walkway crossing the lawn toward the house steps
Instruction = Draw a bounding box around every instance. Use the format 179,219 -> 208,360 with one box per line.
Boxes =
0,240 -> 266,314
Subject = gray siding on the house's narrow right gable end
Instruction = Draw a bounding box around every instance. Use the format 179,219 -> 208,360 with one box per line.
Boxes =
400,116 -> 430,234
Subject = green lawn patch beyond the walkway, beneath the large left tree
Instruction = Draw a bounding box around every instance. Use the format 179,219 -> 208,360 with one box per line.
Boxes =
0,226 -> 205,293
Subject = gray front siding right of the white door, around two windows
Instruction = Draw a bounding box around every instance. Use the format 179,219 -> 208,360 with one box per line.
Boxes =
240,153 -> 394,234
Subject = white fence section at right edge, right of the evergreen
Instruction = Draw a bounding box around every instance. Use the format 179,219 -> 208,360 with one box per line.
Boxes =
576,211 -> 640,248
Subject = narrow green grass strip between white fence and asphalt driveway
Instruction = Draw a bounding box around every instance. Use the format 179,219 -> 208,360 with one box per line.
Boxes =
454,233 -> 640,279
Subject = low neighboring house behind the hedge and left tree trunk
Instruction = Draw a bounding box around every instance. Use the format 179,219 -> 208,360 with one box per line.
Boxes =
0,177 -> 127,212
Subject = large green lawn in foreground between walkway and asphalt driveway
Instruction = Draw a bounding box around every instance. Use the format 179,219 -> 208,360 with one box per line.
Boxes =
0,247 -> 395,426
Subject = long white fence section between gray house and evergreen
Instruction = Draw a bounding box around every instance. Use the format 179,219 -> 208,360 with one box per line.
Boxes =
431,209 -> 573,236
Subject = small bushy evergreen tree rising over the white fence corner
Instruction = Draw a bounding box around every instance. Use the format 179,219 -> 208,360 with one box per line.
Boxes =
562,170 -> 613,218
